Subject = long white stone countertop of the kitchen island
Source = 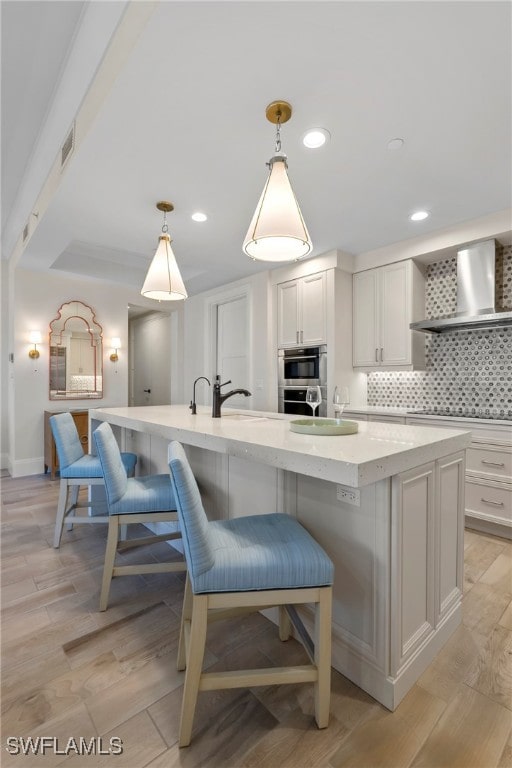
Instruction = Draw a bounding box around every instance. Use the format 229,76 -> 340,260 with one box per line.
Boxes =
89,405 -> 471,488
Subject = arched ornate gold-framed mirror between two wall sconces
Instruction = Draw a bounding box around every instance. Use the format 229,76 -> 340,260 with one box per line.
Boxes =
49,301 -> 103,400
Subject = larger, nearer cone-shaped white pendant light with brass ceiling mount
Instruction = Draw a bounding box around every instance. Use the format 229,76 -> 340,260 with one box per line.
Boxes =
243,101 -> 313,261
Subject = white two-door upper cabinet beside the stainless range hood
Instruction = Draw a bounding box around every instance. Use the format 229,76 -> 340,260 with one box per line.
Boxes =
353,260 -> 425,370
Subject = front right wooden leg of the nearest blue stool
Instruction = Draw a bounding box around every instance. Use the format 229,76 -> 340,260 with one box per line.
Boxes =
315,587 -> 332,728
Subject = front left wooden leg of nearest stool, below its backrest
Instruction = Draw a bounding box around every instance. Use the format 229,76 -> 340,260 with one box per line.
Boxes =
179,595 -> 208,747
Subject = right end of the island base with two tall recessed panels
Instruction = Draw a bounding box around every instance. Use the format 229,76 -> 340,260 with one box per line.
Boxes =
390,453 -> 464,675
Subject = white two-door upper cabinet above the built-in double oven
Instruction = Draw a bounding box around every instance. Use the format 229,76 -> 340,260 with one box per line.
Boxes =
277,272 -> 327,347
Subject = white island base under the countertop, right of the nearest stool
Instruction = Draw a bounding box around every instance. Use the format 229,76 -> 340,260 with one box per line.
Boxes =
294,451 -> 464,709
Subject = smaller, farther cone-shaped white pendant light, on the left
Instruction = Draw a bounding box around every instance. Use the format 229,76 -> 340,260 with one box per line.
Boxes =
141,200 -> 188,301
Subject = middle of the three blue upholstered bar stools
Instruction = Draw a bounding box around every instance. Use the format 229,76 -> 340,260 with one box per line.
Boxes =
93,422 -> 187,611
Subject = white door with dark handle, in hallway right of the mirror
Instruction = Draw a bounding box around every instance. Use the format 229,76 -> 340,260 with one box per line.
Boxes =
130,312 -> 171,405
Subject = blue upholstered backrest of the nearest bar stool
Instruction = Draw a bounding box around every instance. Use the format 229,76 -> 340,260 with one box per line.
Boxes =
168,441 -> 215,582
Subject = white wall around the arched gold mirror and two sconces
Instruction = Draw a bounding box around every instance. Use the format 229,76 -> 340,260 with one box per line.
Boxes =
8,269 -> 133,477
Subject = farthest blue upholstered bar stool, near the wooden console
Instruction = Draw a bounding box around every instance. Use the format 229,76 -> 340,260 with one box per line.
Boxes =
50,413 -> 137,549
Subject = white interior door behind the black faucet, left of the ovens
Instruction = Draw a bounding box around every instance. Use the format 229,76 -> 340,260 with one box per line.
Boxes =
216,296 -> 251,408
